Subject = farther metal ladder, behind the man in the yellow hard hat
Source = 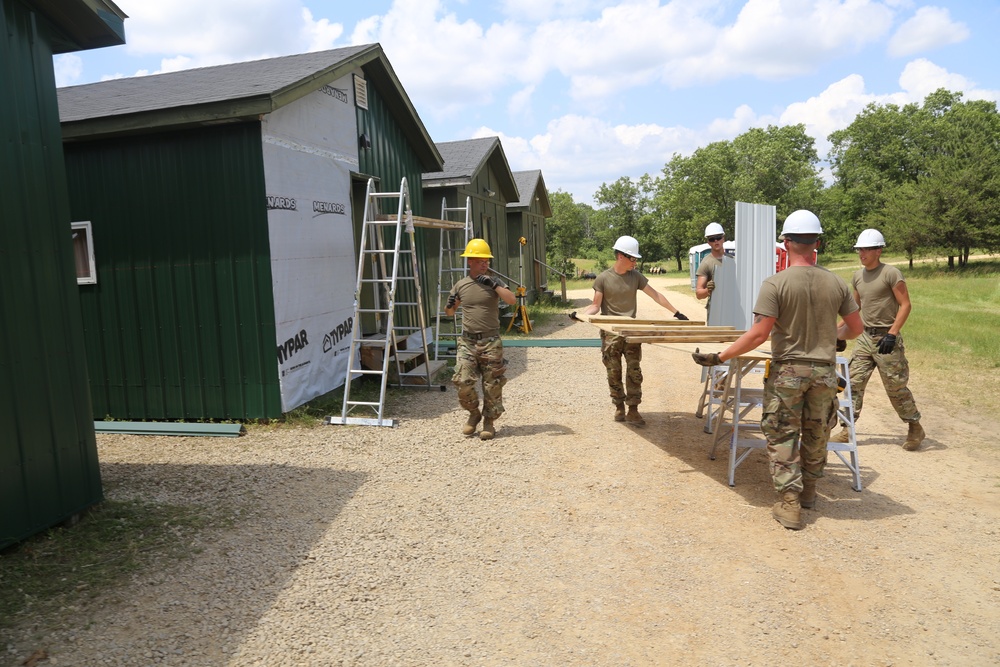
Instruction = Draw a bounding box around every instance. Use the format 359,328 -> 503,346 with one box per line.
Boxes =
434,197 -> 472,359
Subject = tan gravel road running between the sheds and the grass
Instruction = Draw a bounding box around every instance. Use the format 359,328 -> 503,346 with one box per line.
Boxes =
0,278 -> 1000,667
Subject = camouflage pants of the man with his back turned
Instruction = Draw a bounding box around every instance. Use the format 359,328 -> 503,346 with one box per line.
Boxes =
760,362 -> 837,493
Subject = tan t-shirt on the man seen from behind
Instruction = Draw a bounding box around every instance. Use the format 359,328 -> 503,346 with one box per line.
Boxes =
753,266 -> 858,364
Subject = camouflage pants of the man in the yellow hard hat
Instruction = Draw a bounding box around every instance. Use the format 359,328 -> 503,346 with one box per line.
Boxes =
451,336 -> 507,419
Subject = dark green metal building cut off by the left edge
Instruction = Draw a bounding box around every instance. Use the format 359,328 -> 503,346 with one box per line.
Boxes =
0,0 -> 125,548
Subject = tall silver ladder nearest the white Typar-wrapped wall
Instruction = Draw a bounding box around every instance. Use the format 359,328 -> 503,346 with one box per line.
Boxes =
329,178 -> 444,426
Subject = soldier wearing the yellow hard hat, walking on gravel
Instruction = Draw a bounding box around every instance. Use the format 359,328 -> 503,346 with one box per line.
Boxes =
445,239 -> 516,440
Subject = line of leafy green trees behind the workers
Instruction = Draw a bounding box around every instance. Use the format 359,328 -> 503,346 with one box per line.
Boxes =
546,89 -> 1000,275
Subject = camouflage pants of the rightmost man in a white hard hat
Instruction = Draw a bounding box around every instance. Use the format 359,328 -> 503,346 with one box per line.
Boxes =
851,331 -> 920,422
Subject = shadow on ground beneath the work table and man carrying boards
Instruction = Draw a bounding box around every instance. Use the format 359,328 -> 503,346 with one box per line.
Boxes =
631,411 -> 926,520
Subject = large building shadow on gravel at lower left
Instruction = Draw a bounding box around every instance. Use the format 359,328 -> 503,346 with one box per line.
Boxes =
27,464 -> 368,665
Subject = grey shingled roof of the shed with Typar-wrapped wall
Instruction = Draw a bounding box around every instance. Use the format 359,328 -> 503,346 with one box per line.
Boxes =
57,44 -> 443,169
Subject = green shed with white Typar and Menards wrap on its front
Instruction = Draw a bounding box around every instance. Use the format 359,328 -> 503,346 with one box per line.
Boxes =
59,44 -> 443,420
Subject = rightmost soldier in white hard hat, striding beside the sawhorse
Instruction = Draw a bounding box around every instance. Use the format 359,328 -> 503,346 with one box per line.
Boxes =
833,229 -> 924,451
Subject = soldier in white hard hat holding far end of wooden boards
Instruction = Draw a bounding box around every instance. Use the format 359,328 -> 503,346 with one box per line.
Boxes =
570,236 -> 687,426
